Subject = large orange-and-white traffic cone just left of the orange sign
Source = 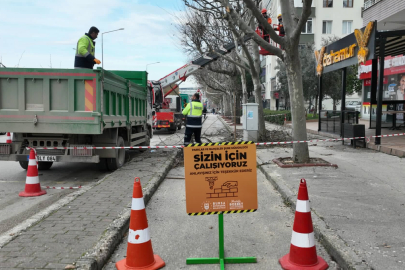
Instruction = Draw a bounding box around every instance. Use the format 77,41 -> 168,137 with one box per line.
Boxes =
115,177 -> 165,270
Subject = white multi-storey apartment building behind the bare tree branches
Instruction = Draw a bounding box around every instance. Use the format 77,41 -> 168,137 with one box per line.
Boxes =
262,0 -> 362,110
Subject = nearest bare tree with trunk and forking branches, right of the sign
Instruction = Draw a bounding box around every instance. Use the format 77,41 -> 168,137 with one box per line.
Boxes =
218,0 -> 312,163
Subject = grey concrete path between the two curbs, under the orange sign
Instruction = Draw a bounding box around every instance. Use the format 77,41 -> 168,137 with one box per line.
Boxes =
104,167 -> 339,270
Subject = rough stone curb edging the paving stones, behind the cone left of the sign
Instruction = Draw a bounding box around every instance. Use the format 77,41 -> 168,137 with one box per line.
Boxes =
76,151 -> 182,270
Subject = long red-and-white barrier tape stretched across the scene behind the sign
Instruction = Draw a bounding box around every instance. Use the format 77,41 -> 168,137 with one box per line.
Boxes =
27,133 -> 405,150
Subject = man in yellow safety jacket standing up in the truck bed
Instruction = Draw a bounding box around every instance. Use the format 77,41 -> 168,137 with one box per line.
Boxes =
75,26 -> 101,69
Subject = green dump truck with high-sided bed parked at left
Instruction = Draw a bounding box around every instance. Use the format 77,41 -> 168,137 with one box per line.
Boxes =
0,68 -> 152,170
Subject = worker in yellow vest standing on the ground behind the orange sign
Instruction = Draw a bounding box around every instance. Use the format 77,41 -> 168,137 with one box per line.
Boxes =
182,93 -> 203,145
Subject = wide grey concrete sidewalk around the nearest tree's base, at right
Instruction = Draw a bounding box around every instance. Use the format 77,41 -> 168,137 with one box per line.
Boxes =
221,117 -> 405,270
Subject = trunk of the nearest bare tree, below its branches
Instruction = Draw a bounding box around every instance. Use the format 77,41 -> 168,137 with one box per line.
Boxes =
285,46 -> 309,163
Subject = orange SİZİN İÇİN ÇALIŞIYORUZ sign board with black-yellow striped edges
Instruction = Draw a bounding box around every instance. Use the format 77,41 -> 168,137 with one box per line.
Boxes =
184,142 -> 257,215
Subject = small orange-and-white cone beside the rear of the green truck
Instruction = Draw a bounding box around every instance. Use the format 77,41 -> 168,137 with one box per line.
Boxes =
19,149 -> 46,197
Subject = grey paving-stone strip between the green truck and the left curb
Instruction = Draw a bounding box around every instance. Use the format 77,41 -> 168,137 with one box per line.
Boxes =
0,149 -> 177,270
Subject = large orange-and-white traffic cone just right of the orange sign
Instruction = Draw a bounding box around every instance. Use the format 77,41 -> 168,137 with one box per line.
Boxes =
278,179 -> 329,270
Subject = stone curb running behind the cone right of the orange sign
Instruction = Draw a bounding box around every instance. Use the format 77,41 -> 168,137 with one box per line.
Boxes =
256,162 -> 369,270
